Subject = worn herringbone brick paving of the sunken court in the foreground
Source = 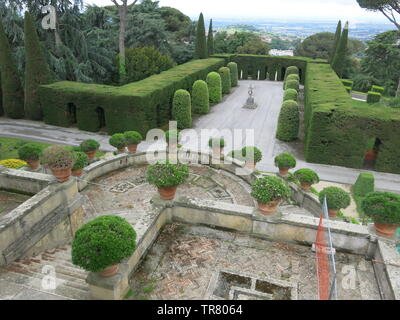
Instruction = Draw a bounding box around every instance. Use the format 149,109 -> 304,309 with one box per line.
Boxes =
128,223 -> 380,300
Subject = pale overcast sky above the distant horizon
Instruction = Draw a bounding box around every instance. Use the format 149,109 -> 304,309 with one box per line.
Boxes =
85,0 -> 386,23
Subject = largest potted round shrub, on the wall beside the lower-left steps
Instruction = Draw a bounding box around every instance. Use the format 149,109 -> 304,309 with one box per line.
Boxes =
72,216 -> 136,277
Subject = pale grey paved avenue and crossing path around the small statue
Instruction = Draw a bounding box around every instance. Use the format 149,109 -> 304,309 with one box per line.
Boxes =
0,80 -> 400,192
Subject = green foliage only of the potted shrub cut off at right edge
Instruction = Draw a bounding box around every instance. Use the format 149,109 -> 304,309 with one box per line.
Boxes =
361,191 -> 400,225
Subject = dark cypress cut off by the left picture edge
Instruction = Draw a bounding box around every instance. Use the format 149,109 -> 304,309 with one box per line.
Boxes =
0,17 -> 24,119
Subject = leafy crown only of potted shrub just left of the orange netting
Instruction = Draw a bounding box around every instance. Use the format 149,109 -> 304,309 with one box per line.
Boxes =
251,176 -> 291,203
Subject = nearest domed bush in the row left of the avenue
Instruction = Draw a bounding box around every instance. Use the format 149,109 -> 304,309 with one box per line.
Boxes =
172,89 -> 192,129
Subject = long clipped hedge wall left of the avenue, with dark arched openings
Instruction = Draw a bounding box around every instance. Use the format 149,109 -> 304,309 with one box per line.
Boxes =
39,58 -> 225,136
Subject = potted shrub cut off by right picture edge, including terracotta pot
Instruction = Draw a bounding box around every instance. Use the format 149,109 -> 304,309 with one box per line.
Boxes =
361,191 -> 400,238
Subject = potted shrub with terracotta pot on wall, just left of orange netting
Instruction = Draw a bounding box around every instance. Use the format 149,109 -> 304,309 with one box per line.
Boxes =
251,176 -> 291,215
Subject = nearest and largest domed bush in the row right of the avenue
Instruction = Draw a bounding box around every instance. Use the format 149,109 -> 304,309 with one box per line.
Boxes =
276,100 -> 300,142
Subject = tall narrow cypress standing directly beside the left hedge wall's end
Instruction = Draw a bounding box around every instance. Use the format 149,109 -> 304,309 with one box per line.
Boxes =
24,12 -> 51,120
